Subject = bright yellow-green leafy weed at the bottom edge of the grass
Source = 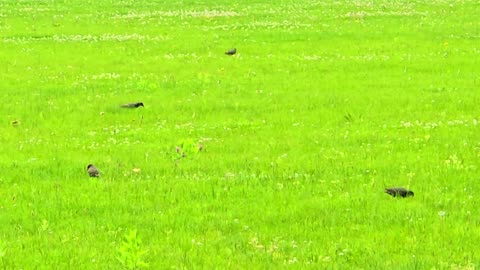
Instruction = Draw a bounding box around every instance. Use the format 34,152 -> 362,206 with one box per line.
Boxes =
117,230 -> 149,269
